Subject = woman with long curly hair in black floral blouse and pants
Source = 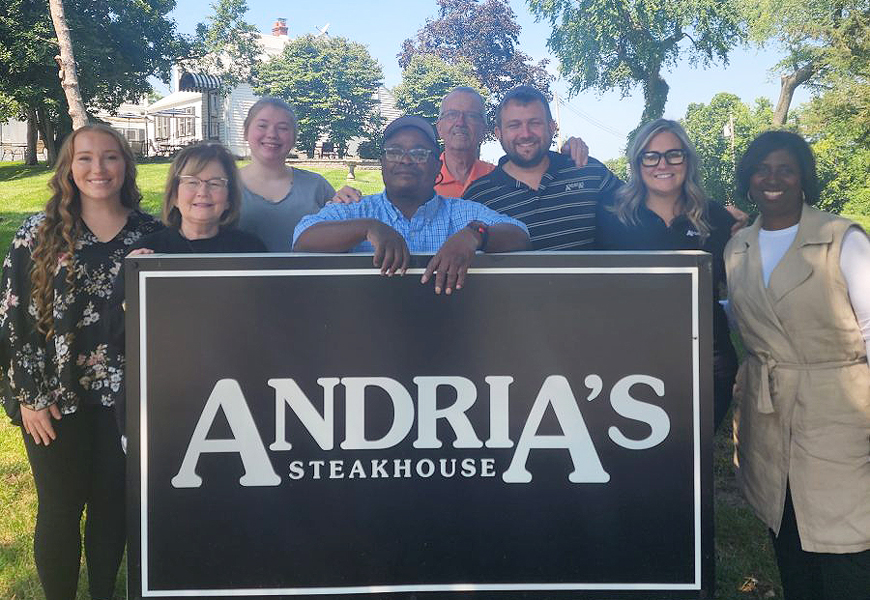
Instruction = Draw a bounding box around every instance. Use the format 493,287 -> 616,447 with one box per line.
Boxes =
0,125 -> 161,600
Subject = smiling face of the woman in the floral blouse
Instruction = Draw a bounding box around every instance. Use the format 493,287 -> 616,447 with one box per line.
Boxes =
71,131 -> 127,204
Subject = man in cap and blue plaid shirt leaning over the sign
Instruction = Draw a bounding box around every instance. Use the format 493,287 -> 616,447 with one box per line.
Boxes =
293,116 -> 529,294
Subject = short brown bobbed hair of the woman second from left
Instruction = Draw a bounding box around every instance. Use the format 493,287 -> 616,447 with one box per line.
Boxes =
163,142 -> 242,229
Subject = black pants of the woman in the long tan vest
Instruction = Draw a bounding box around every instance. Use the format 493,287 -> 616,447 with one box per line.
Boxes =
770,488 -> 870,600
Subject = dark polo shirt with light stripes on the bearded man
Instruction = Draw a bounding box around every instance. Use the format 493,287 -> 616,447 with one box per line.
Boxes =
463,152 -> 622,250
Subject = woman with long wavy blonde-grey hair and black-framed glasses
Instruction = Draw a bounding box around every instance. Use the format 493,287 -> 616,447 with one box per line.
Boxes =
597,119 -> 737,428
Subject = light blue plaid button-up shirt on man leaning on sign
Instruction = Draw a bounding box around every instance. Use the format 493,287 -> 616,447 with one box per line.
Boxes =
293,191 -> 528,254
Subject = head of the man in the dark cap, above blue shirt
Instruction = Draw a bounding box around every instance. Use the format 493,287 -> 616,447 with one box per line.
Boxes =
381,127 -> 441,201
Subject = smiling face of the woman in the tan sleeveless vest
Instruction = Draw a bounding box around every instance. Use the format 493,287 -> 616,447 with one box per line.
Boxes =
749,150 -> 804,229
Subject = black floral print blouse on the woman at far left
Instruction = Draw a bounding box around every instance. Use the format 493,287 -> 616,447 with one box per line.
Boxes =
0,211 -> 163,414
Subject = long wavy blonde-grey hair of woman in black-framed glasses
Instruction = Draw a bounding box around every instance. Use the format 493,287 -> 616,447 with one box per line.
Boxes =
610,119 -> 710,243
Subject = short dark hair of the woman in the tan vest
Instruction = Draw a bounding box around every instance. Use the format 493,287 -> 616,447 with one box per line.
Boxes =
734,129 -> 820,205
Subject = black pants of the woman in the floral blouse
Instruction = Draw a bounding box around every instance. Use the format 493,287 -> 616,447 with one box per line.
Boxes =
24,407 -> 126,600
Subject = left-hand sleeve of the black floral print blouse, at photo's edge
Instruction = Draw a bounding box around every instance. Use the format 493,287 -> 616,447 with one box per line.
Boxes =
0,215 -> 57,410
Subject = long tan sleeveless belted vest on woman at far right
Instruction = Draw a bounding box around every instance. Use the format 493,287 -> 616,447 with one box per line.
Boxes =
725,205 -> 870,553
